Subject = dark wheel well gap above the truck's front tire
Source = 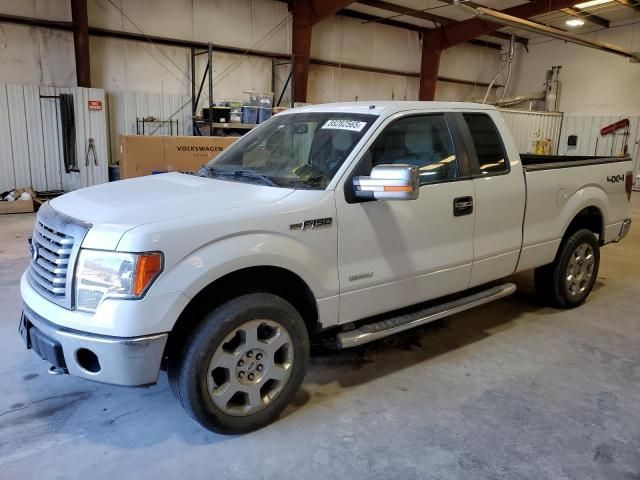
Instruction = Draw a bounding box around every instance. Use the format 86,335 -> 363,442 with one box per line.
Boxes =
165,266 -> 318,355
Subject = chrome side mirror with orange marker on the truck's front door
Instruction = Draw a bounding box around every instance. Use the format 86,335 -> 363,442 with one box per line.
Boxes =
353,165 -> 420,200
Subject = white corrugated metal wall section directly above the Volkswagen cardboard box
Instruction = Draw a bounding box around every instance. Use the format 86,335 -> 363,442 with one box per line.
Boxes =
108,92 -> 193,163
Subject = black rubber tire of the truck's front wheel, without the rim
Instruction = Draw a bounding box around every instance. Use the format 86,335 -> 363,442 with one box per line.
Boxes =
168,293 -> 309,434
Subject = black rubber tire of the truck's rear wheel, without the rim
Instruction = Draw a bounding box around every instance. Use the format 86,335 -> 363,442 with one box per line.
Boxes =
535,229 -> 600,308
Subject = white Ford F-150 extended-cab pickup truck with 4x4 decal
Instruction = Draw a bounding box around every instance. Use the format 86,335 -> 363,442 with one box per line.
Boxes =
20,102 -> 632,433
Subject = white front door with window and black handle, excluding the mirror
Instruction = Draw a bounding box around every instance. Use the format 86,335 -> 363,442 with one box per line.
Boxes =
336,114 -> 475,323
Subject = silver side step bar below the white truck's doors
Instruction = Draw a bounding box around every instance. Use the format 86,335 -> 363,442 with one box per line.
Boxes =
337,283 -> 516,348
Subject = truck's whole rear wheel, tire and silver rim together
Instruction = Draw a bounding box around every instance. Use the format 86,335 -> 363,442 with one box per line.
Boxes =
535,229 -> 600,308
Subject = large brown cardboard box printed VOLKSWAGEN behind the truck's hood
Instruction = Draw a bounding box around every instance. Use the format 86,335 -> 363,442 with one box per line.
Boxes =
118,135 -> 238,179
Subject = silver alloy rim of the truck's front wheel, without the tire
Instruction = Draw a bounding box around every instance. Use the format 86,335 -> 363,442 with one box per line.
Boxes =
207,319 -> 293,416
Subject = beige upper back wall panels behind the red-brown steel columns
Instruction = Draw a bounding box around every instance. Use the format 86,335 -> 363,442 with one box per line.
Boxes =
0,0 -> 499,102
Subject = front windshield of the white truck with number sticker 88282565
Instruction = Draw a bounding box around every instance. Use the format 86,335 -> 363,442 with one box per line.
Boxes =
199,112 -> 377,190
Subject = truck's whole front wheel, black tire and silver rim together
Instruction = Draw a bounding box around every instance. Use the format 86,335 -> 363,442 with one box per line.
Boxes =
169,293 -> 309,433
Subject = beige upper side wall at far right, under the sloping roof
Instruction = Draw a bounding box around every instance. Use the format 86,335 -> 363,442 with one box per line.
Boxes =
509,23 -> 640,115
